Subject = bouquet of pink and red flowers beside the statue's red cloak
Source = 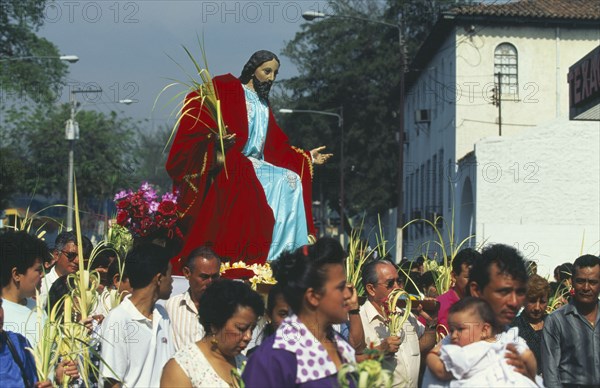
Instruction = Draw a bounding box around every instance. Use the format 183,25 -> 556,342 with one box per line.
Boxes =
115,182 -> 183,239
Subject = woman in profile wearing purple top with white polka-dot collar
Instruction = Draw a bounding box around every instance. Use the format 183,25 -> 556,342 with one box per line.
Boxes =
242,238 -> 355,388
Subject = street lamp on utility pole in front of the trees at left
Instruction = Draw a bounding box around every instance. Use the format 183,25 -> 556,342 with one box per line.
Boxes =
65,89 -> 135,230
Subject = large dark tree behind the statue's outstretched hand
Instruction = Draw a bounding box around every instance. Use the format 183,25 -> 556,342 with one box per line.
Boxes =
277,0 -> 472,218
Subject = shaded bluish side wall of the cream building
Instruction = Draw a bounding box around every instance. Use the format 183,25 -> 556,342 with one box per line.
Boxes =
404,34 -> 456,258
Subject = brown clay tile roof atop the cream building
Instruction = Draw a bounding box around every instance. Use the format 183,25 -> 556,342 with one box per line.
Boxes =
452,0 -> 600,20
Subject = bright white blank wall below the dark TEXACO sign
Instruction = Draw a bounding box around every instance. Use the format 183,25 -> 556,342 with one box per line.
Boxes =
475,119 -> 600,274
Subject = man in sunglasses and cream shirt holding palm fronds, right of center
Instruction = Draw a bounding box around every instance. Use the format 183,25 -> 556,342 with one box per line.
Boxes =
360,260 -> 436,388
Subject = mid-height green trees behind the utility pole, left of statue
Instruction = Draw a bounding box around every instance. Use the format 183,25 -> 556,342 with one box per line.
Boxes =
0,104 -> 172,216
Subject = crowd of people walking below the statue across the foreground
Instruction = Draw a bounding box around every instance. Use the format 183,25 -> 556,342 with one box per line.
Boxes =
0,232 -> 600,387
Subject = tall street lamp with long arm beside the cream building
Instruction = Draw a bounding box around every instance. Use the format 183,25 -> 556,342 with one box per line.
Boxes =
302,11 -> 406,261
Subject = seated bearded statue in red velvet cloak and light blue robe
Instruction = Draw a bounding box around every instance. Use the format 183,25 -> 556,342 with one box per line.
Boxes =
166,50 -> 331,270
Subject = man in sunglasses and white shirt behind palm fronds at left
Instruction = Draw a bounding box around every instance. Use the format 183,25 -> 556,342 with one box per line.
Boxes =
39,232 -> 79,308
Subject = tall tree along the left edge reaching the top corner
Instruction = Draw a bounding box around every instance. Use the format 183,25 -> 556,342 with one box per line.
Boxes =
0,0 -> 67,209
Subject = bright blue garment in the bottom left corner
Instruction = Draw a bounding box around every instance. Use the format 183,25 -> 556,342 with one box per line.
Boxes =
0,331 -> 37,388
